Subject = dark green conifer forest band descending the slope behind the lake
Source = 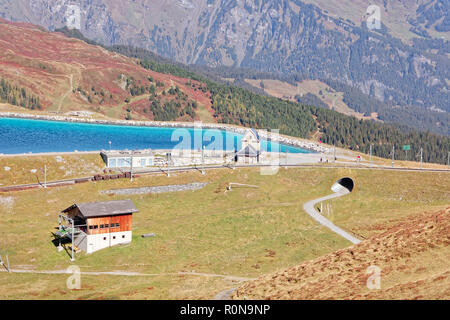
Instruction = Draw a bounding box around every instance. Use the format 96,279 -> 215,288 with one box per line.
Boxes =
53,30 -> 450,163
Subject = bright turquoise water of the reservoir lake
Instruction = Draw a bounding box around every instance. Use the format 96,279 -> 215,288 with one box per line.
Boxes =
0,118 -> 311,154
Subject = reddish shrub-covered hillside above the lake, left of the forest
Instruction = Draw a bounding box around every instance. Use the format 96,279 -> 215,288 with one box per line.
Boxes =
0,20 -> 213,121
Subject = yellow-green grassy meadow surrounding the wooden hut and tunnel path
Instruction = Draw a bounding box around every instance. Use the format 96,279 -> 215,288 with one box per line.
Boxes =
0,169 -> 450,299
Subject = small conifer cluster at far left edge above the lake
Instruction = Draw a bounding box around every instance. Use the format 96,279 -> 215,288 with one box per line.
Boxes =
0,79 -> 42,110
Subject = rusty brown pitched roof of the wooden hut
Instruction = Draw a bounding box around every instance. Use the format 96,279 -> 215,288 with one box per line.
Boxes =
61,200 -> 138,218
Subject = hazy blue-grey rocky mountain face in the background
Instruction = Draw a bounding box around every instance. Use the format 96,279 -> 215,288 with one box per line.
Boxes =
0,0 -> 450,111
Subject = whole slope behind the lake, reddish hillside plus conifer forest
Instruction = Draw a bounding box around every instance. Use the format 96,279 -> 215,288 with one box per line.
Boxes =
0,22 -> 450,163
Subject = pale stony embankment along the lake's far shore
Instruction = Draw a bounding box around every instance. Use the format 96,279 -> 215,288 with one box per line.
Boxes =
0,112 -> 331,153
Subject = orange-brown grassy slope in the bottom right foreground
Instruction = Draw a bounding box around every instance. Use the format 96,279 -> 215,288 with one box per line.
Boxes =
234,208 -> 450,300
